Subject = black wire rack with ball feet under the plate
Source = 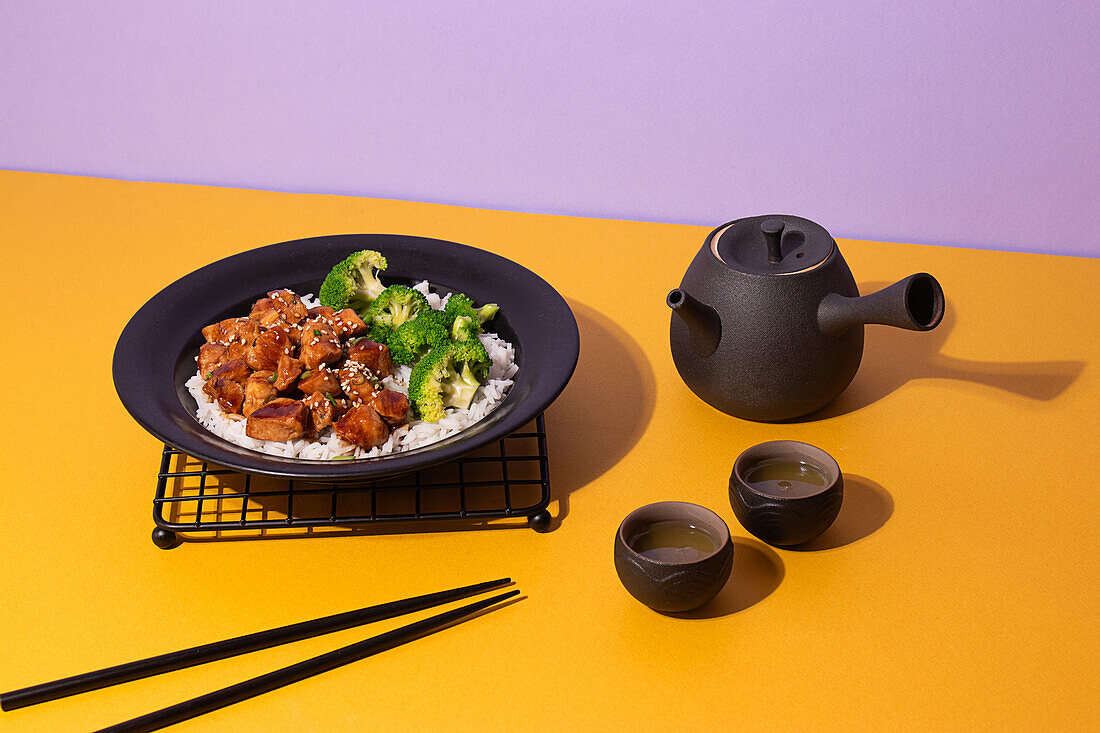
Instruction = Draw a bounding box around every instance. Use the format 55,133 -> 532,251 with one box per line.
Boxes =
153,414 -> 551,549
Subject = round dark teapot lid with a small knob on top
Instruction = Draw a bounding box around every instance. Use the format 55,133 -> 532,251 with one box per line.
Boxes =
707,214 -> 836,275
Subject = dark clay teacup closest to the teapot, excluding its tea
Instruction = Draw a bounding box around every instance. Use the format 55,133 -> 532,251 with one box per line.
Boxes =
729,440 -> 844,547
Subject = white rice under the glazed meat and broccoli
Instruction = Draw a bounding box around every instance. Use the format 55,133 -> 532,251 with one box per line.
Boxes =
187,281 -> 519,460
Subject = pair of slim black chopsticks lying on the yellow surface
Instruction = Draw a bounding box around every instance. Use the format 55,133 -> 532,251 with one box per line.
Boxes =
0,578 -> 519,731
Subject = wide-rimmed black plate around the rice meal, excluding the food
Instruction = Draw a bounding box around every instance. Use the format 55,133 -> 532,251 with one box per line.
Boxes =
113,234 -> 581,481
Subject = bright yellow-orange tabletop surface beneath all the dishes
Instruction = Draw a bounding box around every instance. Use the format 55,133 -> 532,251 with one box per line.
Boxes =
0,168 -> 1100,731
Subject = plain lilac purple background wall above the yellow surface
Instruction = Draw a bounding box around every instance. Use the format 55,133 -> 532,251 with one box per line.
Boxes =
0,0 -> 1100,256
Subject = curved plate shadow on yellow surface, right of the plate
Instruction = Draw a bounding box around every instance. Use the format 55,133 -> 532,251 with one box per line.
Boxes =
546,299 -> 657,528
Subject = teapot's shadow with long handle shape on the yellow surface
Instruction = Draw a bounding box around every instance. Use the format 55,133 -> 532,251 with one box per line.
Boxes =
784,282 -> 1086,423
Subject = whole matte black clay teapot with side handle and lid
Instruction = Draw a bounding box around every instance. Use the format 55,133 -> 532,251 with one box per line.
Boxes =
667,215 -> 944,422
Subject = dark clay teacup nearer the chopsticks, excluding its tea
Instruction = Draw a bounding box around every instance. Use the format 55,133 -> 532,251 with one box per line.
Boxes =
615,502 -> 734,613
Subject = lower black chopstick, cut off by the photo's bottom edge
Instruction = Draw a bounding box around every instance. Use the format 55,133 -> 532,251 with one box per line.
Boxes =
92,590 -> 519,733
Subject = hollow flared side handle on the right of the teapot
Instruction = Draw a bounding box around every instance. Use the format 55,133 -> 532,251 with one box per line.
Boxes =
817,272 -> 945,338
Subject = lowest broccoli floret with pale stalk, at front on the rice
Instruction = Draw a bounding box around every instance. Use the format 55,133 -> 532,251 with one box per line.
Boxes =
409,340 -> 490,423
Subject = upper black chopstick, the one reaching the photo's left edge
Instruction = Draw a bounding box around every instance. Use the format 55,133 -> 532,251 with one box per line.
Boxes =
0,578 -> 512,710
